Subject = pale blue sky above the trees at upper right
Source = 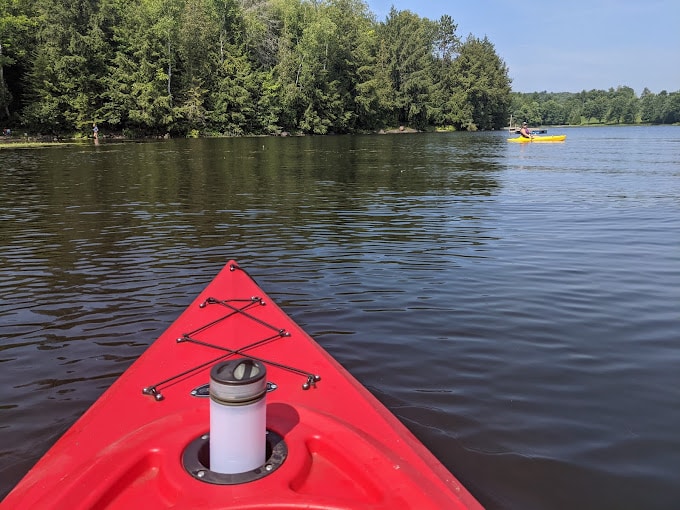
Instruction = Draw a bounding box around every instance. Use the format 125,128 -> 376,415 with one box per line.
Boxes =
366,0 -> 680,95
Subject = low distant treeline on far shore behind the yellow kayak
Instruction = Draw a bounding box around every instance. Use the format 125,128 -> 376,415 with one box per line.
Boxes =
510,87 -> 680,126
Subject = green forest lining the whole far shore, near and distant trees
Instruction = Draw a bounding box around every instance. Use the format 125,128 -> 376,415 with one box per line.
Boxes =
0,0 -> 680,136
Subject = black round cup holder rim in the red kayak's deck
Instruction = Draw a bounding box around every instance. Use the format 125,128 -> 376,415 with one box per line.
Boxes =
182,430 -> 288,485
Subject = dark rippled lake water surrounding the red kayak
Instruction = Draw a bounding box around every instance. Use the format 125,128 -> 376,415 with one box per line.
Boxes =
0,127 -> 680,510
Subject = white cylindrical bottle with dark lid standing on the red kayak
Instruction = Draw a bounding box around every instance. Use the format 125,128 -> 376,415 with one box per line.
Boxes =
210,358 -> 267,474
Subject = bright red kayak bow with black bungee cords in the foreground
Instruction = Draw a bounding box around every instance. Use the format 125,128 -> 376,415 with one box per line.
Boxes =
1,261 -> 481,510
